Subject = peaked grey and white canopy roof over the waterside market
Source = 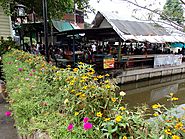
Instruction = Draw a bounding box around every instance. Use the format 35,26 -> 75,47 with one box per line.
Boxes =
92,12 -> 185,43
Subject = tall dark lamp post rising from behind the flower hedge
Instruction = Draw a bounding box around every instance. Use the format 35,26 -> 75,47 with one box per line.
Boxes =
42,0 -> 49,62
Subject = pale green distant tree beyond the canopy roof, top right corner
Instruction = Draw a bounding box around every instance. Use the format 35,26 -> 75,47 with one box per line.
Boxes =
161,0 -> 184,24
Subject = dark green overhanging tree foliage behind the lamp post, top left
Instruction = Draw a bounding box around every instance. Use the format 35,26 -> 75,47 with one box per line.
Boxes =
0,0 -> 90,18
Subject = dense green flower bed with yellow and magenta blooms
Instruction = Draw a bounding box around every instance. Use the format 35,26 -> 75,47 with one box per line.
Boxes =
3,50 -> 185,139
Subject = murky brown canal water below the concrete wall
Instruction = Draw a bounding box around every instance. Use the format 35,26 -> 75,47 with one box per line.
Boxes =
120,74 -> 185,108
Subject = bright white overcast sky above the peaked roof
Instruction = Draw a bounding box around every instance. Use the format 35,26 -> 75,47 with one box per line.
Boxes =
85,0 -> 166,23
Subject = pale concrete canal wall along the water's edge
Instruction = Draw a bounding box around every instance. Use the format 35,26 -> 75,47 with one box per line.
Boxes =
116,63 -> 185,84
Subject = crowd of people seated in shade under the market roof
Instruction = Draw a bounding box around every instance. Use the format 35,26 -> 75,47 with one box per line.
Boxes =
23,42 -> 185,68
